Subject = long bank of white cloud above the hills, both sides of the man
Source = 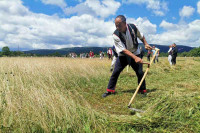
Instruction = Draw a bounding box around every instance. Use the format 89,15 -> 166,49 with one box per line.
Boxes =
0,0 -> 200,49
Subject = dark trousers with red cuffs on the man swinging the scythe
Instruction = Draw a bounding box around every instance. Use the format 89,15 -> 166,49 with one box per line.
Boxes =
107,55 -> 146,92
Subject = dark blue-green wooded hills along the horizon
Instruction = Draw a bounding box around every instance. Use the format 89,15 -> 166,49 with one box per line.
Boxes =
24,44 -> 193,55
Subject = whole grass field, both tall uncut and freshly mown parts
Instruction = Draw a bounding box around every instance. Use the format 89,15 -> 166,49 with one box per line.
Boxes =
0,57 -> 200,133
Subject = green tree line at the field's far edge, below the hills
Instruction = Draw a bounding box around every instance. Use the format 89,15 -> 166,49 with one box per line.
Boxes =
0,46 -> 200,57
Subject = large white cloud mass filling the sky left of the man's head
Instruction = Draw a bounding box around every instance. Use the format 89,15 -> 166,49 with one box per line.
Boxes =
0,0 -> 115,49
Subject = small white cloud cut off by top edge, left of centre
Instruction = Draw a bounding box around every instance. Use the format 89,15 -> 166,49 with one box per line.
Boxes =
41,0 -> 67,8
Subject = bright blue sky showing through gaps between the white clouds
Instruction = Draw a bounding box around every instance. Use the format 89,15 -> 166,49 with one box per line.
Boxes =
23,0 -> 200,32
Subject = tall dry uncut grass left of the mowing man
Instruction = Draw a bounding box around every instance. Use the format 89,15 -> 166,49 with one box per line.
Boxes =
0,58 -> 113,132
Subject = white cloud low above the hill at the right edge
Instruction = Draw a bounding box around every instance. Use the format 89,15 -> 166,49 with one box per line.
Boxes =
149,20 -> 200,47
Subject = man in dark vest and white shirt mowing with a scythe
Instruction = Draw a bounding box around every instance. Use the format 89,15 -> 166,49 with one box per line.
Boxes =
102,15 -> 152,97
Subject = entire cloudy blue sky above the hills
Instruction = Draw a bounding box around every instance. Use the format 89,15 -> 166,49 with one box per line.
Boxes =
0,0 -> 200,50
